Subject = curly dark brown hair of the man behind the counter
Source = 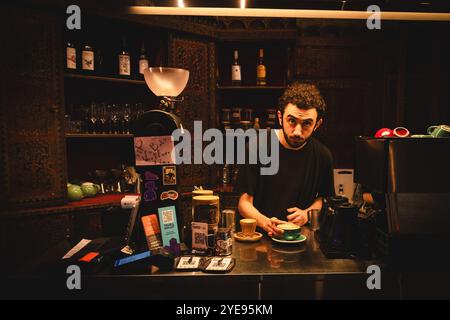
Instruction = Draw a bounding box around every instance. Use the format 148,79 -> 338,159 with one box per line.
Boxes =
278,82 -> 326,120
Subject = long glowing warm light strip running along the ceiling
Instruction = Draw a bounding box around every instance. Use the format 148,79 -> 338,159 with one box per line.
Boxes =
128,6 -> 450,21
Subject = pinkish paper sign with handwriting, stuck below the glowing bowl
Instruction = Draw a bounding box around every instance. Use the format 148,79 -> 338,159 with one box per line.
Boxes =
134,136 -> 175,166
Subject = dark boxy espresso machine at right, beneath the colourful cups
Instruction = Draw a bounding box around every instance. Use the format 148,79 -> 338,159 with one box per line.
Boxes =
355,137 -> 450,272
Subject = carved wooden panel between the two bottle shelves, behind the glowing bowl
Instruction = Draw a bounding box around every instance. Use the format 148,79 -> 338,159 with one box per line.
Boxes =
169,37 -> 214,192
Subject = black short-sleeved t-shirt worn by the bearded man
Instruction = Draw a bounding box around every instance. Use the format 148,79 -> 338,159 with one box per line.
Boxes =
237,134 -> 334,220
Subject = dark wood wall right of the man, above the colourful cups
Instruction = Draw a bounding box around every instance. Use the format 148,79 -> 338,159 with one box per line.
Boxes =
294,21 -> 450,168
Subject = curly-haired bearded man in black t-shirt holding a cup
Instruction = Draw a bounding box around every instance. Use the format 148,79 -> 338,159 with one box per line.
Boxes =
238,82 -> 334,237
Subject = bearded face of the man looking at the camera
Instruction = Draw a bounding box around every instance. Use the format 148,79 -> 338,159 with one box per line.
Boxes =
278,103 -> 322,148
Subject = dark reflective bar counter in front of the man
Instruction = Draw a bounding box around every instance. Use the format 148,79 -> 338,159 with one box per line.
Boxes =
3,227 -> 399,300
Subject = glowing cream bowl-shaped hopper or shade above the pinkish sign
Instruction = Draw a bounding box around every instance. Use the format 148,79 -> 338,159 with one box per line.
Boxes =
144,67 -> 189,97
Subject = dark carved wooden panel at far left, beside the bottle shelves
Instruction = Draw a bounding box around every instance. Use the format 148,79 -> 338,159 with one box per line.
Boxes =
0,8 -> 66,207
